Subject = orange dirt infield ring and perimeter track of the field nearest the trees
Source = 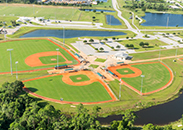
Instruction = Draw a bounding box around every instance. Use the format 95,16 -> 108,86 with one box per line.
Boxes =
22,71 -> 117,105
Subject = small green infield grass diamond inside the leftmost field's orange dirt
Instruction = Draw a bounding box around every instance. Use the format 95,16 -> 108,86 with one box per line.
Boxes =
39,55 -> 65,64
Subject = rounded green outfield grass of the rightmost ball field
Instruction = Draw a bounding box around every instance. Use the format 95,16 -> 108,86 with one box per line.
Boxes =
122,63 -> 170,93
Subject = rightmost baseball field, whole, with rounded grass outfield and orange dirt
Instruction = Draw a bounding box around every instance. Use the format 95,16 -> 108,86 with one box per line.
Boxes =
108,62 -> 173,95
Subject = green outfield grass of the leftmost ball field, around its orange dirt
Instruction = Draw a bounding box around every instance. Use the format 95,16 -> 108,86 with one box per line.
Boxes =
0,40 -> 77,72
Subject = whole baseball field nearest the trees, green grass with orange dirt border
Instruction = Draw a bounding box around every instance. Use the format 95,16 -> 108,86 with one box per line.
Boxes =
23,70 -> 117,104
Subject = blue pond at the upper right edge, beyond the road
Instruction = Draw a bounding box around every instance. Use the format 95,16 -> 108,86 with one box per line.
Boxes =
141,13 -> 183,27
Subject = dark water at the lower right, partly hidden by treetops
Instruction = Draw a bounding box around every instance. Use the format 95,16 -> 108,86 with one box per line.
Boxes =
98,94 -> 183,125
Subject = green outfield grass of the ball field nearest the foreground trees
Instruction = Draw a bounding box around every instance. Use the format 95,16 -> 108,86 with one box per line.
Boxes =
25,75 -> 111,102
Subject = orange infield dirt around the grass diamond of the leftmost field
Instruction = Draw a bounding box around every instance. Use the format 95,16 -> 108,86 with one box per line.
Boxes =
25,51 -> 72,67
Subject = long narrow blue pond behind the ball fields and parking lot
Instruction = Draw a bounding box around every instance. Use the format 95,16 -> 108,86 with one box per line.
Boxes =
20,30 -> 126,38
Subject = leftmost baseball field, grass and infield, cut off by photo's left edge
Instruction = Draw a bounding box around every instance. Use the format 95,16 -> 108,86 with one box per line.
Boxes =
0,39 -> 78,72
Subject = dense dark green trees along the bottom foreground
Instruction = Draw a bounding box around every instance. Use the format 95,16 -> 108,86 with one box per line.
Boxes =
0,80 -> 176,130
